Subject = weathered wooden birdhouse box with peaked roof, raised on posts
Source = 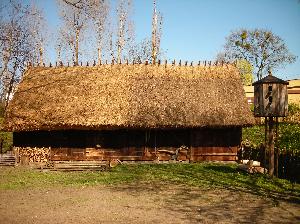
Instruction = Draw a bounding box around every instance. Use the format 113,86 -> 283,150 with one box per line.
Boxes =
253,72 -> 289,117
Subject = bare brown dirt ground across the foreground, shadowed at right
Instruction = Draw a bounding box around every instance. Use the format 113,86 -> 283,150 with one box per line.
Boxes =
0,185 -> 300,224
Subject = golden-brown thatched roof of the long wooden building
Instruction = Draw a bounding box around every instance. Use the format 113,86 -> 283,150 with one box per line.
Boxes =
5,64 -> 254,131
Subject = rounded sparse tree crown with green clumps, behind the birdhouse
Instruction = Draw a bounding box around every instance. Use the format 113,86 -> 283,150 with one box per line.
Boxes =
224,29 -> 296,79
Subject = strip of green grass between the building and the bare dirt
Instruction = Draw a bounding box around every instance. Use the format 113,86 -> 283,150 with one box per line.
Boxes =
0,163 -> 300,202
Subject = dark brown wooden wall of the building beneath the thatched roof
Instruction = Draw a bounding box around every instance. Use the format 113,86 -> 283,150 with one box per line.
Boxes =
13,128 -> 241,162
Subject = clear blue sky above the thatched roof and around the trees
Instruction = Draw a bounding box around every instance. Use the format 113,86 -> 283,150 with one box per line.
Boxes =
37,0 -> 300,80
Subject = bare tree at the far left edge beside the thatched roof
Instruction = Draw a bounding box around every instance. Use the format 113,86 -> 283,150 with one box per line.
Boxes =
0,0 -> 44,108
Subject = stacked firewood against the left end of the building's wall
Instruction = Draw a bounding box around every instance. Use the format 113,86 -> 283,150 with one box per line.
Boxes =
15,147 -> 51,162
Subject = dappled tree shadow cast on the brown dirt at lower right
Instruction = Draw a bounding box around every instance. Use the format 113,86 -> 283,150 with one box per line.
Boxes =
112,182 -> 300,223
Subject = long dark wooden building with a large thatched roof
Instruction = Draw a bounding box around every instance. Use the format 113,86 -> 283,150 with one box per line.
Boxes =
5,64 -> 254,162
